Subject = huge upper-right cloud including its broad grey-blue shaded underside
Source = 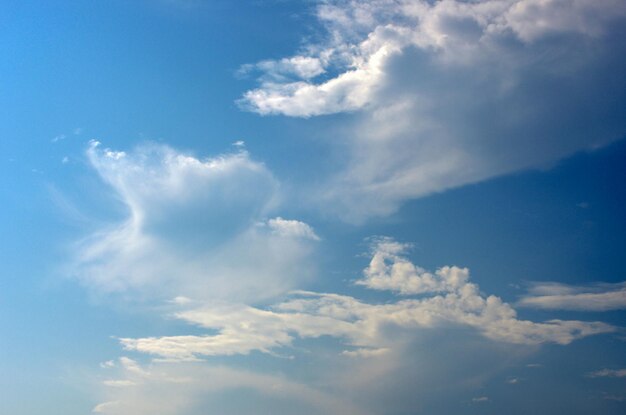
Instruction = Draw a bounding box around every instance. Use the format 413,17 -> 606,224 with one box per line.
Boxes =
239,0 -> 626,222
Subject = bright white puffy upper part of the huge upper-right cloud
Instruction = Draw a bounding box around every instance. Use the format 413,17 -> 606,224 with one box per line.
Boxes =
244,0 -> 626,117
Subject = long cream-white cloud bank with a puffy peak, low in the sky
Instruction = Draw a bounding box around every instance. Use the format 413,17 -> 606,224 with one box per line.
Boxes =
120,238 -> 616,361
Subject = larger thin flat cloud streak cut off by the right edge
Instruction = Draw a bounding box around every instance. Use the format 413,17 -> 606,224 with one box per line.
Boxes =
518,282 -> 626,311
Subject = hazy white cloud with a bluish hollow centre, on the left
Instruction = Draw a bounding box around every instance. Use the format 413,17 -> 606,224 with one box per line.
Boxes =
70,142 -> 315,301
